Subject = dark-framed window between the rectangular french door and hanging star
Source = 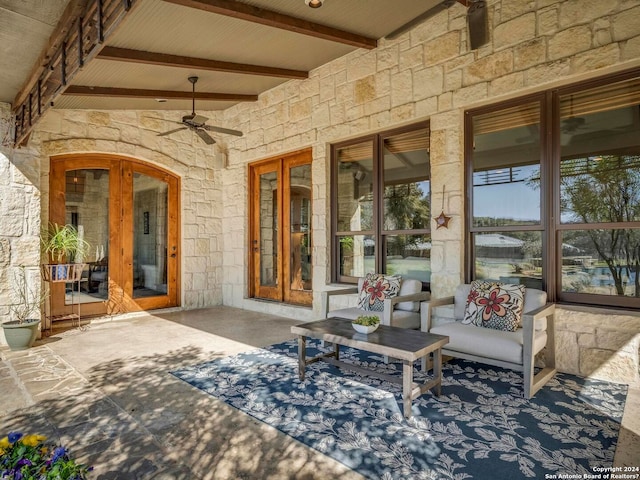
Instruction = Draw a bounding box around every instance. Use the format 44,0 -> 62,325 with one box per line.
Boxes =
331,123 -> 431,285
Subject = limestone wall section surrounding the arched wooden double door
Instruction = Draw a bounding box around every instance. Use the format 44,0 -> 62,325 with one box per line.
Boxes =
30,110 -> 228,308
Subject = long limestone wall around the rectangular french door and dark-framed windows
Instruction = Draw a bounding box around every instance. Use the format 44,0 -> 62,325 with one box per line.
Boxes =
214,0 -> 640,382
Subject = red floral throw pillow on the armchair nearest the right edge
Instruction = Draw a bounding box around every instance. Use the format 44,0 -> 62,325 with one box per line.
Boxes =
462,280 -> 524,332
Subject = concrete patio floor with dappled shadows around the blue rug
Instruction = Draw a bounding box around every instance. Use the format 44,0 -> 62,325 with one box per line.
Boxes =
0,307 -> 640,480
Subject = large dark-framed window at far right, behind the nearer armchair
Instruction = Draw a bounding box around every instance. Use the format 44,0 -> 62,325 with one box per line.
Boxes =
466,70 -> 640,307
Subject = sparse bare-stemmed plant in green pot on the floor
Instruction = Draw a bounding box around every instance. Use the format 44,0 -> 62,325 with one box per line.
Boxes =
2,265 -> 47,350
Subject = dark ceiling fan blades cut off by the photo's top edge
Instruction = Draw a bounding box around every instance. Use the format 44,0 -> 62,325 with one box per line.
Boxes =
385,0 -> 489,50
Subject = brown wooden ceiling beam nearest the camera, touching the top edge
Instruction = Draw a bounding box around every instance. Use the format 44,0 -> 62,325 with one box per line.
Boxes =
164,0 -> 378,50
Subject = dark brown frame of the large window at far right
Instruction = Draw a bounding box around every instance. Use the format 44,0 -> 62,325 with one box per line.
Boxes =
464,68 -> 640,308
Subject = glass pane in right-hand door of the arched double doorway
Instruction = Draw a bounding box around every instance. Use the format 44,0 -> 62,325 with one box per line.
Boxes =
132,172 -> 169,298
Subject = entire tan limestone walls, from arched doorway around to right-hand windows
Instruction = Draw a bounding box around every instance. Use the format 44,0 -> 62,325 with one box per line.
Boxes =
0,0 -> 640,382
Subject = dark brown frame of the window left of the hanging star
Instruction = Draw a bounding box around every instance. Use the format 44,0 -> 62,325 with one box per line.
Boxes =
329,120 -> 431,284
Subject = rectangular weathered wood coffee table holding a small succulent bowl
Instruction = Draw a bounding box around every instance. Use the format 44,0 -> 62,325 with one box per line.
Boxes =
291,318 -> 449,418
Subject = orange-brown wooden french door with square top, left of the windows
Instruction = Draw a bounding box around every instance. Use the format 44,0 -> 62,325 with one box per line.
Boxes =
249,150 -> 312,305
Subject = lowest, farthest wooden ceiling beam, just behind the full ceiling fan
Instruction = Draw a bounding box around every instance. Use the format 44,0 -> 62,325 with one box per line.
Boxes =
62,85 -> 258,102
